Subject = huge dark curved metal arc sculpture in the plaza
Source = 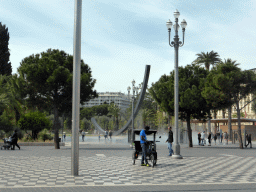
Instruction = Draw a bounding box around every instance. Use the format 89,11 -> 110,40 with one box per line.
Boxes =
91,65 -> 150,136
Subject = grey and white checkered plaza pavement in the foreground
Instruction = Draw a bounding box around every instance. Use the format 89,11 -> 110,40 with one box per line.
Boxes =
0,142 -> 256,191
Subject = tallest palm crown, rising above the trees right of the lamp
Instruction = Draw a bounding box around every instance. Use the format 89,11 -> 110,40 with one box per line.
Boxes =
193,51 -> 221,71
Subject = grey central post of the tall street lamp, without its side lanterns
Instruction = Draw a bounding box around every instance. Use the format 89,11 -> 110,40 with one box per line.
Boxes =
172,18 -> 182,159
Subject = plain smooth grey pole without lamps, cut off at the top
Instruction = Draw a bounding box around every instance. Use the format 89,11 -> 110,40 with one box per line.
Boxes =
71,0 -> 82,176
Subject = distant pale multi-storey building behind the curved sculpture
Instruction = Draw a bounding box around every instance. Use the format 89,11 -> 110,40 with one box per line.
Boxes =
83,92 -> 131,111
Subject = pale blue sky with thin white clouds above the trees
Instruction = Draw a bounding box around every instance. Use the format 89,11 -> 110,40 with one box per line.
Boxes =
0,0 -> 256,93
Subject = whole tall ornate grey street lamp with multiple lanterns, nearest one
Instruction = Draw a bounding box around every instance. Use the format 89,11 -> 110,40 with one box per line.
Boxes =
166,9 -> 187,159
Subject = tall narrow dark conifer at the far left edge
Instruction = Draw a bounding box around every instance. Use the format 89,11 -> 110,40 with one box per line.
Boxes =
0,22 -> 12,75
